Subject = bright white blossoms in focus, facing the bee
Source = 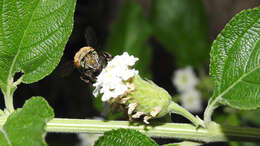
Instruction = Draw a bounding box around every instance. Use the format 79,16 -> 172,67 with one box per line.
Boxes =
93,52 -> 138,101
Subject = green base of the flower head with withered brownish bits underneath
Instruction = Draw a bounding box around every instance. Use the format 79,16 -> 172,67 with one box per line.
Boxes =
121,75 -> 171,124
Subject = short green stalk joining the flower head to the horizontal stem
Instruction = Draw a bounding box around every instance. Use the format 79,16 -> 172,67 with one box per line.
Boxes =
168,101 -> 205,127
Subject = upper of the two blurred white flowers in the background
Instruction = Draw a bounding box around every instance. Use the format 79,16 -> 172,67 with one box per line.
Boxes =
172,67 -> 199,92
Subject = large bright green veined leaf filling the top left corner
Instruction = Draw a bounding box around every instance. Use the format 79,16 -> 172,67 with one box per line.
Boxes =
0,0 -> 76,94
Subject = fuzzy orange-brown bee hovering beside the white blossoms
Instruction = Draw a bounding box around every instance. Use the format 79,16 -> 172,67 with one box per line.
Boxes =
74,28 -> 112,84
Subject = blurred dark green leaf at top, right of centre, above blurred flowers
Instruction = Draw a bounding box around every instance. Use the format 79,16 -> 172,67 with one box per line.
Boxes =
150,0 -> 209,66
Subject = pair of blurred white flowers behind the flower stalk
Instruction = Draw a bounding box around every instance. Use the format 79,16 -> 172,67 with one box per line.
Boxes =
172,67 -> 202,112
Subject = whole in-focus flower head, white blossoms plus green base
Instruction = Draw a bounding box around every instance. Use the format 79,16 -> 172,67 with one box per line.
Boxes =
93,53 -> 171,124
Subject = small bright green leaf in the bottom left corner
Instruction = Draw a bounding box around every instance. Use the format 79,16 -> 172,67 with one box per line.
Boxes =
0,97 -> 54,146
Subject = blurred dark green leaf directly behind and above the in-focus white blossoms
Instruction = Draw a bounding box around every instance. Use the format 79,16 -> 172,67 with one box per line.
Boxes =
107,0 -> 151,78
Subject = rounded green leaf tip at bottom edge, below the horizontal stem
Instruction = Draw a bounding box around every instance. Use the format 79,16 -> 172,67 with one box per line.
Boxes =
95,129 -> 158,146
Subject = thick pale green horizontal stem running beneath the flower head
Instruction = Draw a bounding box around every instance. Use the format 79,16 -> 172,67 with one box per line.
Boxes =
0,117 -> 260,142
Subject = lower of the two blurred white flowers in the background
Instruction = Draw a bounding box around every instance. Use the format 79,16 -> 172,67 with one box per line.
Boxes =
180,89 -> 202,113
